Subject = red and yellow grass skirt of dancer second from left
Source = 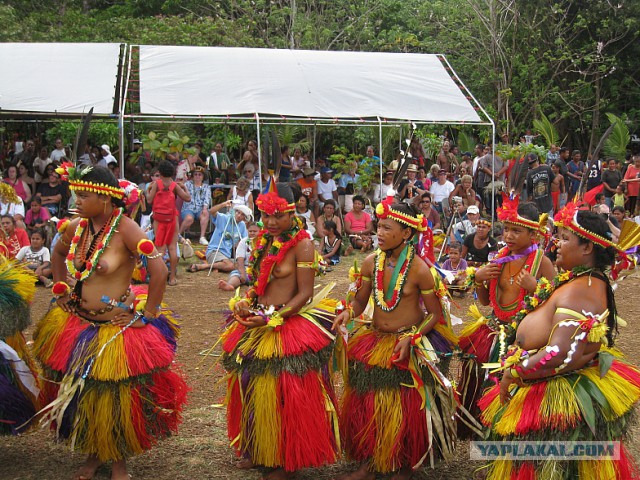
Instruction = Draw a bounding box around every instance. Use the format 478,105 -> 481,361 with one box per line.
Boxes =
221,299 -> 340,471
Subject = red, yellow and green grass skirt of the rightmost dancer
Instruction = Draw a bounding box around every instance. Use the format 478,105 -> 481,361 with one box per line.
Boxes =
478,354 -> 640,480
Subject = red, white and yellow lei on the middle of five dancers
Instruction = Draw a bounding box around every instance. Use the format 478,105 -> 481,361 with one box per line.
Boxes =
373,243 -> 415,312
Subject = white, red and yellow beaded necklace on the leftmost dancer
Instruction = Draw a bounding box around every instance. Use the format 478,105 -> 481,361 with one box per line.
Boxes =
65,208 -> 123,282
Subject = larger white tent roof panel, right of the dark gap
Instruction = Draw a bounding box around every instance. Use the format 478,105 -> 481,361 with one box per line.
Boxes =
140,46 -> 484,123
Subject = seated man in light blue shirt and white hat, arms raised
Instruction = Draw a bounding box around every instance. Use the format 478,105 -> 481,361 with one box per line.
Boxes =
188,200 -> 253,272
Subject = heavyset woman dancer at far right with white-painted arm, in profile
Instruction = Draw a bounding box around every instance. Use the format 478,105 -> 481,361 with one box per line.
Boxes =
479,204 -> 640,480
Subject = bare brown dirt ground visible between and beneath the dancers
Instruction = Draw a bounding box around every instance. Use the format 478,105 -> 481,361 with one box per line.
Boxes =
0,253 -> 640,480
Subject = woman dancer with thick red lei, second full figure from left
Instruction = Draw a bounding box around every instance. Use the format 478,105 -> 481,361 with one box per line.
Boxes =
222,183 -> 339,480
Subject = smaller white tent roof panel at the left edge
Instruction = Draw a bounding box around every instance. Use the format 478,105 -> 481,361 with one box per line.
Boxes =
0,43 -> 120,114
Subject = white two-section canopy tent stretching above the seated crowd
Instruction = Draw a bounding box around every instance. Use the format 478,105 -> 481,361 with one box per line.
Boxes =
0,43 -> 495,191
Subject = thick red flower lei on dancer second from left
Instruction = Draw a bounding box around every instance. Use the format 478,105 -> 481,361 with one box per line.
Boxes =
247,217 -> 310,295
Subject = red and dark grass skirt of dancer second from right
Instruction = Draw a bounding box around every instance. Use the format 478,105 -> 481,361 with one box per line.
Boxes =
458,307 -> 515,438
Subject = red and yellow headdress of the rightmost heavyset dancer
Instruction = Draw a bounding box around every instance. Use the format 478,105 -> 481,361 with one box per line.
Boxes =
553,202 -> 640,280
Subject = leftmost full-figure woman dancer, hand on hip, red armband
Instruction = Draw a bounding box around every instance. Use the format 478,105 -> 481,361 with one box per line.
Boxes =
34,164 -> 187,479
